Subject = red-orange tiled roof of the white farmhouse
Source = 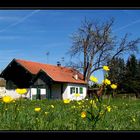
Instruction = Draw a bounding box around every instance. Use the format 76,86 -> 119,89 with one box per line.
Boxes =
15,59 -> 86,84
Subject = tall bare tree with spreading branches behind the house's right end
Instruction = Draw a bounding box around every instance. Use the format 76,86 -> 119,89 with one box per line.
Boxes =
68,18 -> 140,81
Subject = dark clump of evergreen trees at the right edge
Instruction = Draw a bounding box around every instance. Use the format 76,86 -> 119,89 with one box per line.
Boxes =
108,54 -> 140,97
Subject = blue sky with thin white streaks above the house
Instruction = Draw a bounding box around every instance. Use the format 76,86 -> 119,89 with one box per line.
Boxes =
0,9 -> 140,81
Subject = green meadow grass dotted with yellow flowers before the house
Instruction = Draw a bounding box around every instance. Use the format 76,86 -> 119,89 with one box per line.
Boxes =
0,98 -> 140,130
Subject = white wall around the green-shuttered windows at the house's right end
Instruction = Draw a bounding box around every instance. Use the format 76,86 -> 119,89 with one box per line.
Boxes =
62,84 -> 87,100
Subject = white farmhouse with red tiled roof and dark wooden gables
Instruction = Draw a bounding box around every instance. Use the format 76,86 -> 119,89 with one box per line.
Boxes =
0,59 -> 87,100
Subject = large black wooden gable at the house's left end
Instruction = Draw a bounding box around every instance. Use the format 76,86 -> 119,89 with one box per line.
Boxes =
1,59 -> 35,89
